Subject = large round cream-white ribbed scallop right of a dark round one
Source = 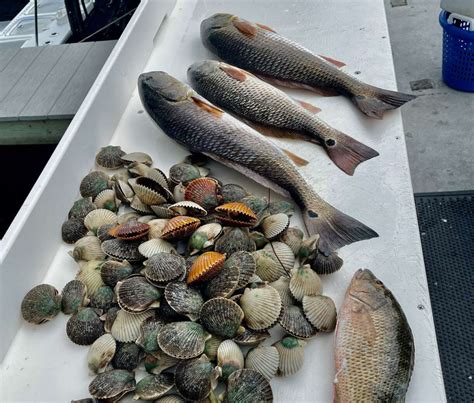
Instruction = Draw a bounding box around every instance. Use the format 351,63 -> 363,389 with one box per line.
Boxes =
239,285 -> 282,330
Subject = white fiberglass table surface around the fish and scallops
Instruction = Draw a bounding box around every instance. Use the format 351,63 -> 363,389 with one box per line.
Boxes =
0,0 -> 445,402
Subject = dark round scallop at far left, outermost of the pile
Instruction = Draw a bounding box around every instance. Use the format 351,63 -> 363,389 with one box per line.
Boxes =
21,284 -> 61,325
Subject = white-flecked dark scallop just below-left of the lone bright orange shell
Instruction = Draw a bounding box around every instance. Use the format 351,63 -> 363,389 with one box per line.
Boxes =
165,281 -> 204,320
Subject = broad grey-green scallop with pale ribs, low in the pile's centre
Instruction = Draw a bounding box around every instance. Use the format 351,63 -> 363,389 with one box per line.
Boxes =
158,322 -> 209,360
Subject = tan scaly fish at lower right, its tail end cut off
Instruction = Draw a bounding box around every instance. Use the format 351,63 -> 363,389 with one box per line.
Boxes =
334,270 -> 415,403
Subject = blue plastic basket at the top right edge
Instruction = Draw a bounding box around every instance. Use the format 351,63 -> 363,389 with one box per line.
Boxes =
439,10 -> 474,92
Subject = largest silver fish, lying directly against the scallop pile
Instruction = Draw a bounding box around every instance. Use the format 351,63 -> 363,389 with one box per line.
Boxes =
138,71 -> 378,254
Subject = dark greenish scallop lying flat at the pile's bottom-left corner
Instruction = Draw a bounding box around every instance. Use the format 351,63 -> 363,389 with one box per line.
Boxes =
89,369 -> 135,401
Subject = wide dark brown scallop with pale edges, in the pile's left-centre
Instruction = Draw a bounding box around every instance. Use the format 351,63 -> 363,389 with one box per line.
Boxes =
115,276 -> 161,313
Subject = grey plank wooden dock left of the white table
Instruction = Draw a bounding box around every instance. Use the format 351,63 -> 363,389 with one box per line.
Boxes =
0,41 -> 116,145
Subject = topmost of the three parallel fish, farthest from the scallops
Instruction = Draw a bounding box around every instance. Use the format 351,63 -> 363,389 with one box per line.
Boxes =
201,14 -> 415,119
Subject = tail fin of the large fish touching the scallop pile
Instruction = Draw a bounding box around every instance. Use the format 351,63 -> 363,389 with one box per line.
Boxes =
303,199 -> 379,255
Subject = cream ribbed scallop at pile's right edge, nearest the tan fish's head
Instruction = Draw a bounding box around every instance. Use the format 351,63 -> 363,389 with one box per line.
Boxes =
303,295 -> 337,332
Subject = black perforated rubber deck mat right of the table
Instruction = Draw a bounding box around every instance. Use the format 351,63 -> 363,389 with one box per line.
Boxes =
415,191 -> 474,402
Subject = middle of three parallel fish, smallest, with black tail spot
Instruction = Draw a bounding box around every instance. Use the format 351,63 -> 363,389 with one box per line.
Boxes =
188,60 -> 379,175
